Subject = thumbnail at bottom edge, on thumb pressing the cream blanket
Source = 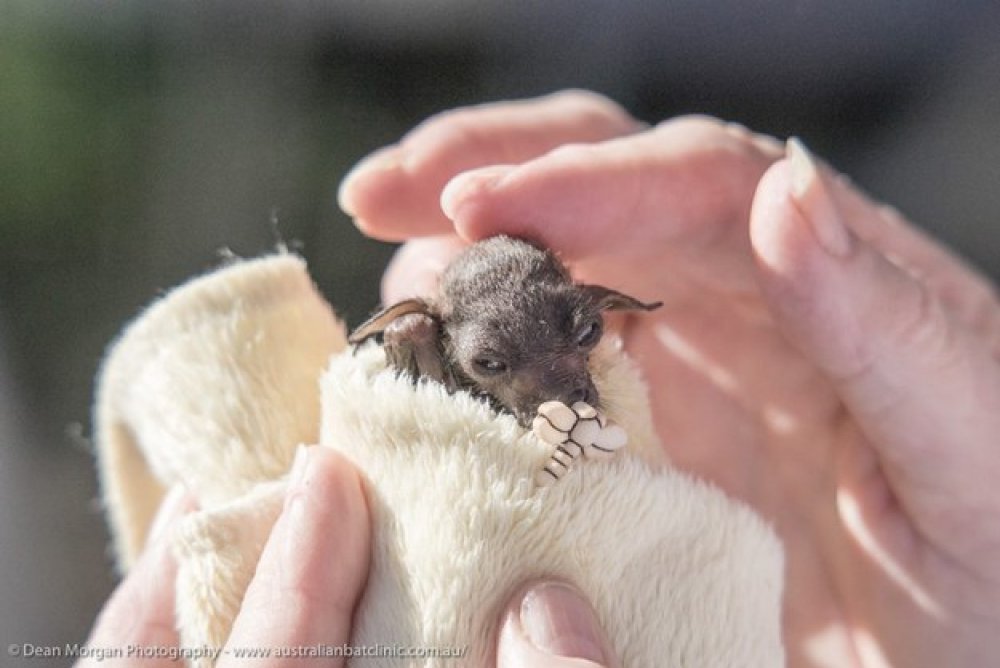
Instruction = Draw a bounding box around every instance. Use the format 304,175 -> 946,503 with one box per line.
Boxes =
521,582 -> 609,663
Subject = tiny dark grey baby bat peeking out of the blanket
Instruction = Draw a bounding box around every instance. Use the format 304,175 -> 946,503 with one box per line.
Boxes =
348,236 -> 661,427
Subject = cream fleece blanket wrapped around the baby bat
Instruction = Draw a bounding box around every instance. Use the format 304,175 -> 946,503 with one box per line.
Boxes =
95,254 -> 784,668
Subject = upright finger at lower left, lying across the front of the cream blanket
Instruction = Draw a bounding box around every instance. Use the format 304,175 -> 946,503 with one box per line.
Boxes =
218,446 -> 370,668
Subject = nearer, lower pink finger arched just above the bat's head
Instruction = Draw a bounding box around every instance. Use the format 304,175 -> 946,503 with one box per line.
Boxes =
441,117 -> 781,259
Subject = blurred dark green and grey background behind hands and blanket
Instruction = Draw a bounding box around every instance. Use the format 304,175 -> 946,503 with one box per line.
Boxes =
0,0 -> 1000,665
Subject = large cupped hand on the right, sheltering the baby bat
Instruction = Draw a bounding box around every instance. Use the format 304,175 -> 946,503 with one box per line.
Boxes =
340,93 -> 1000,666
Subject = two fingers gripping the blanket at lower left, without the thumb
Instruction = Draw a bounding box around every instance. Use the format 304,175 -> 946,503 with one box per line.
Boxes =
77,447 -> 370,668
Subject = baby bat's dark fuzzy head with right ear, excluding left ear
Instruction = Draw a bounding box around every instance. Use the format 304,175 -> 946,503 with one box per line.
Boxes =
440,237 -> 659,427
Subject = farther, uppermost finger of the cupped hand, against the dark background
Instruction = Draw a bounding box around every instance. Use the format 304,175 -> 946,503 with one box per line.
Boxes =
339,91 -> 641,241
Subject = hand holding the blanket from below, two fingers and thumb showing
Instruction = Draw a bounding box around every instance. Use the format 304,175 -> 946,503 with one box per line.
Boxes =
82,446 -> 618,668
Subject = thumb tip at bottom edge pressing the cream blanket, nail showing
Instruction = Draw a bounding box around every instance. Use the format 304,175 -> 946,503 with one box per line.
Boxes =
497,582 -> 619,668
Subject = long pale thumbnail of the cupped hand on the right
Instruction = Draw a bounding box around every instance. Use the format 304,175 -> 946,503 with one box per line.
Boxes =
785,137 -> 853,257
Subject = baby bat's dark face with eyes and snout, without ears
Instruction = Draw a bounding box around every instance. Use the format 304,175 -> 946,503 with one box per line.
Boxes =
447,285 -> 604,426
